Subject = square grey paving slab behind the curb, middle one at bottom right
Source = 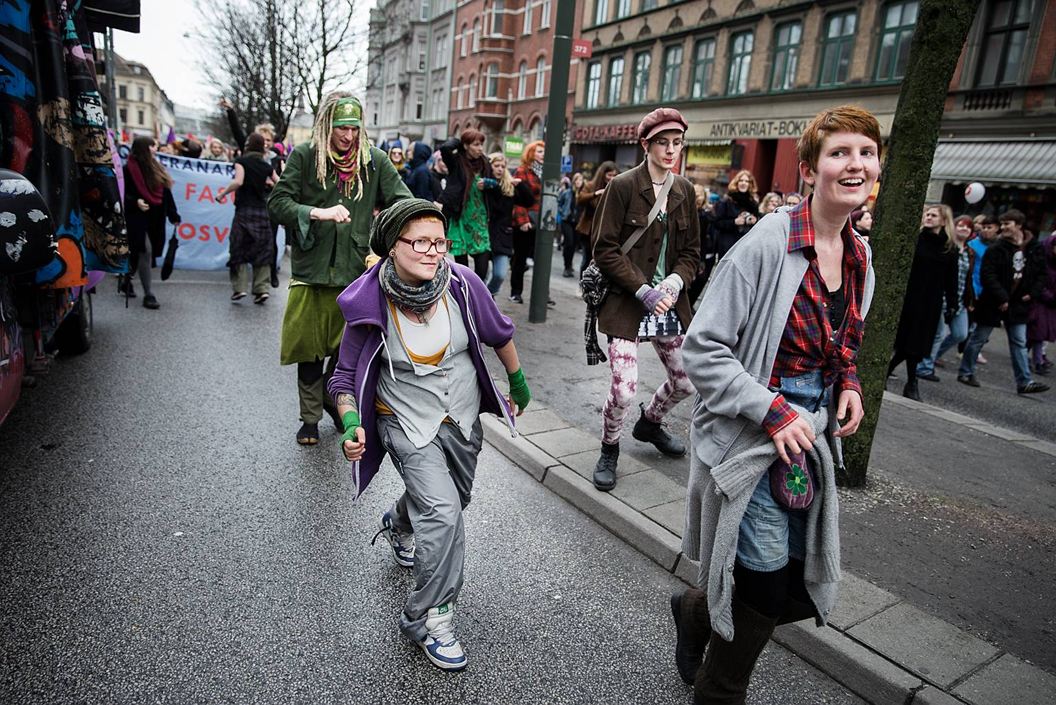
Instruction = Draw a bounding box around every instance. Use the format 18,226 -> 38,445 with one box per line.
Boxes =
847,603 -> 998,689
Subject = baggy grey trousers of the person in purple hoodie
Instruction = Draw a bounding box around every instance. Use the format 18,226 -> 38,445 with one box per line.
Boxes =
378,416 -> 484,642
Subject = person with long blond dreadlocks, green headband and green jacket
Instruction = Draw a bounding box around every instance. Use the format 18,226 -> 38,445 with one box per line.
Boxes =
267,91 -> 411,445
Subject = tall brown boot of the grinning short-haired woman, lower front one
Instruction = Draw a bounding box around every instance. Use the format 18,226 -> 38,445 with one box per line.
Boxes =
693,595 -> 777,705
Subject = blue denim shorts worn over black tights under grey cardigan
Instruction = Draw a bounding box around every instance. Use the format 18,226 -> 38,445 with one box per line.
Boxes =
737,370 -> 831,572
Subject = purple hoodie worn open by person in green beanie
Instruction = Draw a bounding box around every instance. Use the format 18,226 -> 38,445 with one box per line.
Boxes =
326,261 -> 516,498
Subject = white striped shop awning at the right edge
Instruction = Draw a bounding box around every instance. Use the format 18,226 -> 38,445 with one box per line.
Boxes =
931,139 -> 1056,186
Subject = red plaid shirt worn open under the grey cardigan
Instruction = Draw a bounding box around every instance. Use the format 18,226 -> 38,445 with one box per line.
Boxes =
762,198 -> 868,436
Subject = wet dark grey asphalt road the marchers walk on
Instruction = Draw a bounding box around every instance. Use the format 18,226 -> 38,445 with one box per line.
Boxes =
0,272 -> 861,705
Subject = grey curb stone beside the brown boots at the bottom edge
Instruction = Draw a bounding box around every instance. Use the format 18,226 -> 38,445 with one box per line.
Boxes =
773,622 -> 923,705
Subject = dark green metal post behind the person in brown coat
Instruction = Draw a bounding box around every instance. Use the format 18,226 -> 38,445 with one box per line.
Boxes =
528,0 -> 576,323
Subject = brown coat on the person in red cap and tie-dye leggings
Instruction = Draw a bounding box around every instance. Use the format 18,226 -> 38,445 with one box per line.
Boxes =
590,161 -> 700,340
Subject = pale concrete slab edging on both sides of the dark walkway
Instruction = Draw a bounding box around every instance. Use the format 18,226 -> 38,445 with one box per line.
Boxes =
482,395 -> 1056,705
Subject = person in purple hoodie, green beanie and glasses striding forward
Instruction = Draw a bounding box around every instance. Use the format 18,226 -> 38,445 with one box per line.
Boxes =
327,198 -> 531,670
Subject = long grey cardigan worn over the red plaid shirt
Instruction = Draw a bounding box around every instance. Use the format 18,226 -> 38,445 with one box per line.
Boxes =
682,208 -> 875,641
